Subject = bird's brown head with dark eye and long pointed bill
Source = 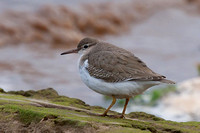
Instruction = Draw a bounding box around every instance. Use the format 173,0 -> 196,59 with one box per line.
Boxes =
61,37 -> 98,55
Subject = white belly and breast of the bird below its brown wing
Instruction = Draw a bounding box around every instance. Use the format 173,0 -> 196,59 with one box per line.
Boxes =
79,60 -> 160,98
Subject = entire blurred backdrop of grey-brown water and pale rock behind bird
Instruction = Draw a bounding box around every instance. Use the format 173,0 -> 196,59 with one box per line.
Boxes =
0,0 -> 200,121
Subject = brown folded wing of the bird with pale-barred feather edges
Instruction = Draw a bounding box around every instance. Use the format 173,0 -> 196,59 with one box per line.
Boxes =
87,49 -> 165,82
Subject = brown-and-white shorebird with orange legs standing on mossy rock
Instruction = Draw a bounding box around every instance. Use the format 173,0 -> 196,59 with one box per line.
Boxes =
61,37 -> 175,118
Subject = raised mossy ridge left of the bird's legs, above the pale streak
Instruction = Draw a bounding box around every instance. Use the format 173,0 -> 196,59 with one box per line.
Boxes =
2,88 -> 108,113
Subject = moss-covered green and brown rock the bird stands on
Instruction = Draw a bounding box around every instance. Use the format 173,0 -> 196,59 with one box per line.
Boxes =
0,88 -> 200,133
